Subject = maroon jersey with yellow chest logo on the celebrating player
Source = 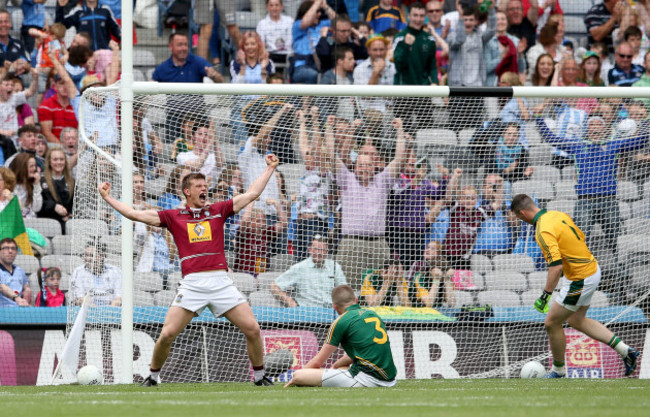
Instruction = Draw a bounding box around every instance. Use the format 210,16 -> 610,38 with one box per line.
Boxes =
158,200 -> 235,276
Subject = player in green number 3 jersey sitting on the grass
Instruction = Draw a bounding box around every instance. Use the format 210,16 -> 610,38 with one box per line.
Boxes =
285,285 -> 397,388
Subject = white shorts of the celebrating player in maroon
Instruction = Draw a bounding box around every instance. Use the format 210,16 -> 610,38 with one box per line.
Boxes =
172,271 -> 246,317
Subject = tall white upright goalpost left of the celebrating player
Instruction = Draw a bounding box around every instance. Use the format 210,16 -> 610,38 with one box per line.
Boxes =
116,0 -> 133,384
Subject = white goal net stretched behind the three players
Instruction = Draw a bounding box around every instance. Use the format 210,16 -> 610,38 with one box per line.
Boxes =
69,88 -> 650,383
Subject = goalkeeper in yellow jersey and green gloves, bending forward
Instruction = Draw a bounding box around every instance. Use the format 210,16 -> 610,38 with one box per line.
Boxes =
510,194 -> 639,378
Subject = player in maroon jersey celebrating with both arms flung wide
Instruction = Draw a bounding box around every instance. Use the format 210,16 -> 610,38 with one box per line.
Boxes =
99,154 -> 279,386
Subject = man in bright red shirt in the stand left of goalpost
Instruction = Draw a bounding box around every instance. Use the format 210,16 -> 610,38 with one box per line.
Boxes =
38,75 -> 79,143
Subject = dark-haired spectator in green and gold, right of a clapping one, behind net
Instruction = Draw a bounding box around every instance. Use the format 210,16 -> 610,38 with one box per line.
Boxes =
408,241 -> 456,307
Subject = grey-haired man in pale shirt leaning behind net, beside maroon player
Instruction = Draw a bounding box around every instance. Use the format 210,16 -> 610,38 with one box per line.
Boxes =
271,235 -> 347,308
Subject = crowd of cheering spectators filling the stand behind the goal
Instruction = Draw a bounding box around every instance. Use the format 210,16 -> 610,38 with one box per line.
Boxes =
0,0 -> 650,316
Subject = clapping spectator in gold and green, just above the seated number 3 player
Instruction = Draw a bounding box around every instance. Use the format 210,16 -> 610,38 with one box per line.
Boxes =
359,259 -> 411,307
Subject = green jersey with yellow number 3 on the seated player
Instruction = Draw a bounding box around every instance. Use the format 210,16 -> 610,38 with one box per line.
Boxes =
326,304 -> 397,381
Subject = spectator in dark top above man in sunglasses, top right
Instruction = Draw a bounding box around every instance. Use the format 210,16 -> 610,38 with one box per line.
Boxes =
584,0 -> 627,51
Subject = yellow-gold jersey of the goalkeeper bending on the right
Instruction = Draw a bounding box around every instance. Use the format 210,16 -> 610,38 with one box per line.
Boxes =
533,210 -> 598,281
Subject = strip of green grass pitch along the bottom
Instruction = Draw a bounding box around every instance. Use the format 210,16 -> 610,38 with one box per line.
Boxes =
0,379 -> 650,417
